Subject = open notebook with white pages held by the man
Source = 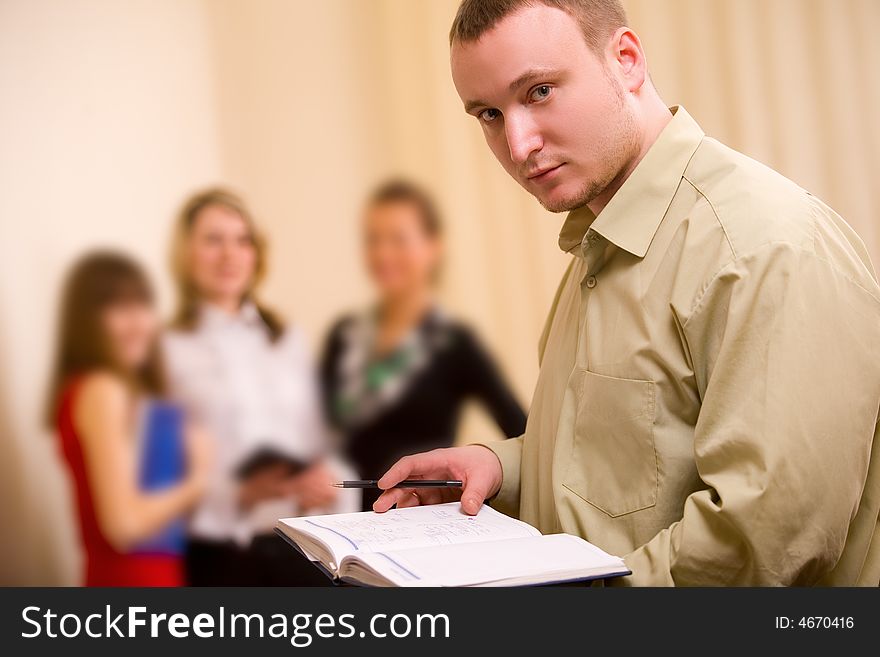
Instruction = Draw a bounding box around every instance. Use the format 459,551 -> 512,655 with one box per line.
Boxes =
275,502 -> 630,586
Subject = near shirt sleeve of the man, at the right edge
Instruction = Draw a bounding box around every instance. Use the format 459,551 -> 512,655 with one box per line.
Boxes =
610,243 -> 880,586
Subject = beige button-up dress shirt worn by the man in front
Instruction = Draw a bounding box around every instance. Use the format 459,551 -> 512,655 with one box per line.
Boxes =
487,107 -> 880,586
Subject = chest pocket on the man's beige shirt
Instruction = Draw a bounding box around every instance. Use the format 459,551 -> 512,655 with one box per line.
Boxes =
562,370 -> 659,517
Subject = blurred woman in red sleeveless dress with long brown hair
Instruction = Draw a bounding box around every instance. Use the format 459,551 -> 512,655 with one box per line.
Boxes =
49,253 -> 210,586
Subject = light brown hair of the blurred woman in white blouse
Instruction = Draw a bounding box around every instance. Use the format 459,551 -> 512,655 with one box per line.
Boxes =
171,187 -> 284,342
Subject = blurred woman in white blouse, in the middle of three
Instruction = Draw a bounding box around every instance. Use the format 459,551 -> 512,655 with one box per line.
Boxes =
164,189 -> 359,586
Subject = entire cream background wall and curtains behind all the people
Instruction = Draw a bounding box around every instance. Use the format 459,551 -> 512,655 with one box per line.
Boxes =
0,0 -> 880,583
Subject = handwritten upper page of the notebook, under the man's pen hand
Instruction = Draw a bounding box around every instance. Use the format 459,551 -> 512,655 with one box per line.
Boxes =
297,502 -> 540,554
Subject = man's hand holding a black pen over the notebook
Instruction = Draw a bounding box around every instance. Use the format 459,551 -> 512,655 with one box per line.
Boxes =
373,445 -> 501,516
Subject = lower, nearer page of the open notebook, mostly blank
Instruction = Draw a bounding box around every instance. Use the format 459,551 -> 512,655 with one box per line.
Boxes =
358,534 -> 626,586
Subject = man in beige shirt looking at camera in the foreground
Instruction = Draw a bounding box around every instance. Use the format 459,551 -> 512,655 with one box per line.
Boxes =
374,0 -> 880,586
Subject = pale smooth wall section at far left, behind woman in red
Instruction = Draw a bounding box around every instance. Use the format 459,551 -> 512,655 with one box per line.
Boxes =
0,0 -> 221,584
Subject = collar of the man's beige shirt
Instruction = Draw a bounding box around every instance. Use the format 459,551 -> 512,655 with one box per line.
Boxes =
559,106 -> 705,258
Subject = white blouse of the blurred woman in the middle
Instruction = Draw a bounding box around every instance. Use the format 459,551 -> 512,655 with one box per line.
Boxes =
162,303 -> 361,545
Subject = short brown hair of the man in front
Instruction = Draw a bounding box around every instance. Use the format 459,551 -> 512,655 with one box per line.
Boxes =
449,0 -> 627,53
